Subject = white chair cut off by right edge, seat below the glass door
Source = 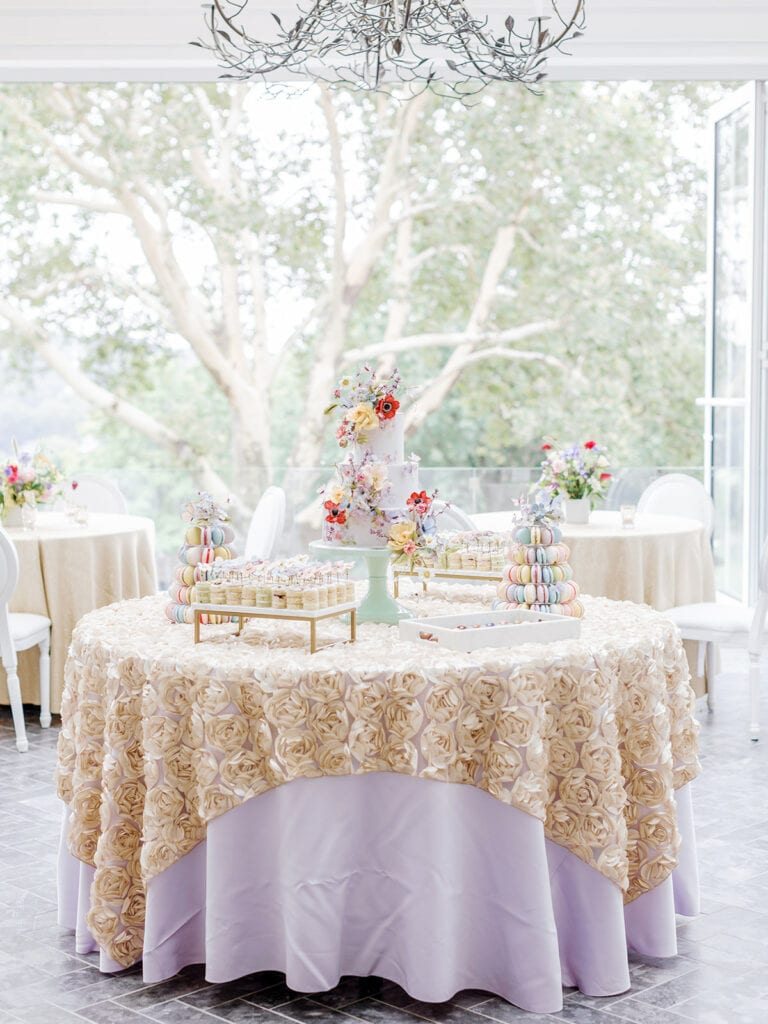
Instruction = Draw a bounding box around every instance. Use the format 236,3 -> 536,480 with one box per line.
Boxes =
664,538 -> 768,741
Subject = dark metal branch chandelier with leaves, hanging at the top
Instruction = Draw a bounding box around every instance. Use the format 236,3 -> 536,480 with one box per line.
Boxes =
193,0 -> 585,97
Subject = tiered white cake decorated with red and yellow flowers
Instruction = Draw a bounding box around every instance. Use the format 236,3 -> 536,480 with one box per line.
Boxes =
323,367 -> 419,548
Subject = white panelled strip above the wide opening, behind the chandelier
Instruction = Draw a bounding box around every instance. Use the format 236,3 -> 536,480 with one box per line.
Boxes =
0,0 -> 768,81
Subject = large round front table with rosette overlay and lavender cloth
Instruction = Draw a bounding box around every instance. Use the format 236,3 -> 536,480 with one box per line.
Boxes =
57,586 -> 698,1013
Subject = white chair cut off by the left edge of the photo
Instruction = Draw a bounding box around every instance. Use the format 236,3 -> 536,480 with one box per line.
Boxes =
0,526 -> 50,752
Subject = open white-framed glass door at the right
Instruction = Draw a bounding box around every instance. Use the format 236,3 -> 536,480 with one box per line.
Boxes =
702,83 -> 766,600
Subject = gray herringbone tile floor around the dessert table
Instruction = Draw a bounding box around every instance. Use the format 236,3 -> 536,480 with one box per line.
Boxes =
0,652 -> 768,1024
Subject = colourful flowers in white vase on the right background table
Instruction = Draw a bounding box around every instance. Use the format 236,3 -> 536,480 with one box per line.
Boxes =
531,438 -> 611,522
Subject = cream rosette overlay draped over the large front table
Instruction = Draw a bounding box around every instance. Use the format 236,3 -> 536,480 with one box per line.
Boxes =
57,587 -> 698,1009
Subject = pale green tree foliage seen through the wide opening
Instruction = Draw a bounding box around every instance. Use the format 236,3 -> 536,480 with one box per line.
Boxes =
0,77 -> 722,488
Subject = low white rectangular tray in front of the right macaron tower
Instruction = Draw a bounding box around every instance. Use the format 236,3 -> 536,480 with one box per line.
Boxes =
399,608 -> 582,650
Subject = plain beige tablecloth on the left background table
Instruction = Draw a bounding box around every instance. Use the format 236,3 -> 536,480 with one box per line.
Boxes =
0,512 -> 158,714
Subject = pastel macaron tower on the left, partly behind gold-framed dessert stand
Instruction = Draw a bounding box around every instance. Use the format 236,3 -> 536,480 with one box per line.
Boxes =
165,492 -> 234,623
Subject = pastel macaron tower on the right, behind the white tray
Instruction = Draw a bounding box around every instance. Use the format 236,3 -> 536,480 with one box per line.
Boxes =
497,496 -> 584,618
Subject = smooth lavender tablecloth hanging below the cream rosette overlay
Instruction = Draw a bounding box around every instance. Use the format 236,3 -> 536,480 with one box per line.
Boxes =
59,773 -> 698,1013
